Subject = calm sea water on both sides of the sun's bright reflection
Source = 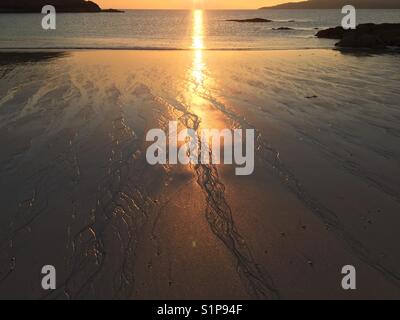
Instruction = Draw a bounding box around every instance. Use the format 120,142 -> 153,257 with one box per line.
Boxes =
0,10 -> 400,50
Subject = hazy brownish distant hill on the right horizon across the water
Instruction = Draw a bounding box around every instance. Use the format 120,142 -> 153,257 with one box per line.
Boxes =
260,0 -> 400,9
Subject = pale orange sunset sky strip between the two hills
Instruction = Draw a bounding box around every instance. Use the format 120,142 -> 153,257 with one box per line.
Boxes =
94,0 -> 300,9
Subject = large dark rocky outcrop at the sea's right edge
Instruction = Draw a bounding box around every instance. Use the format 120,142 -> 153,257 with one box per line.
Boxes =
316,23 -> 400,49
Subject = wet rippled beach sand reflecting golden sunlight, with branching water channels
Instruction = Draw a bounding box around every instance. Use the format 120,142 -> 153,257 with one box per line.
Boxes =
0,50 -> 400,299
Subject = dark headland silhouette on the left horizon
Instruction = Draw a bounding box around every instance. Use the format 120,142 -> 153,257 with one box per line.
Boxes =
0,0 -> 101,13
